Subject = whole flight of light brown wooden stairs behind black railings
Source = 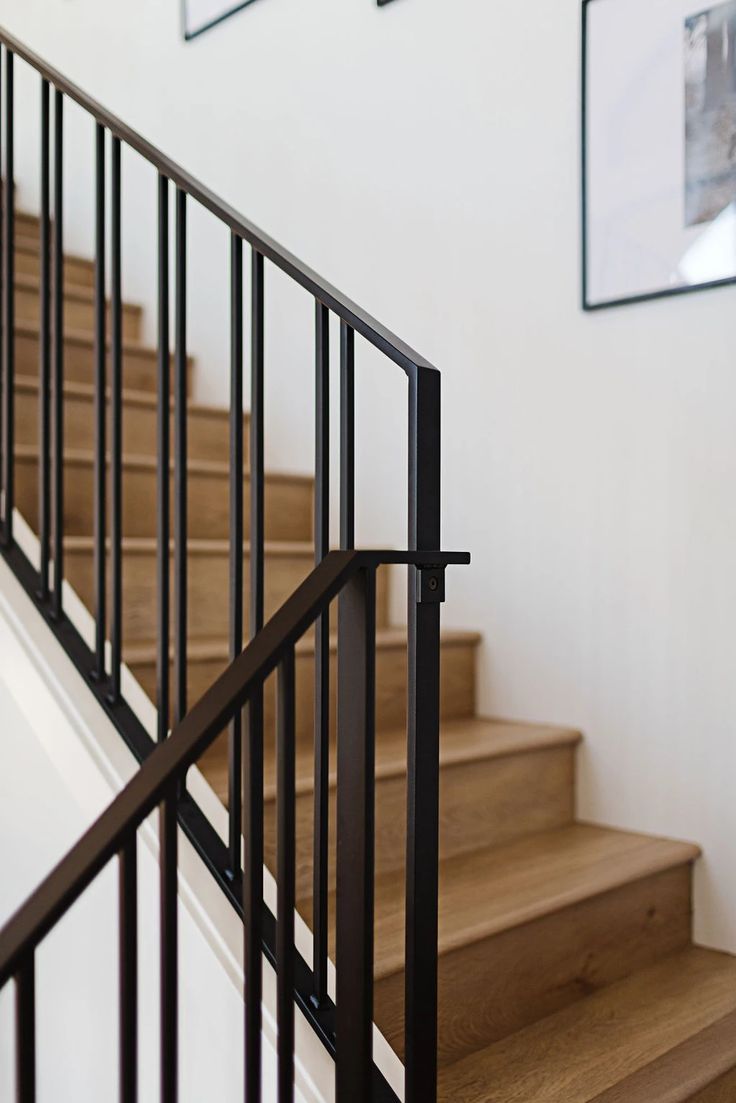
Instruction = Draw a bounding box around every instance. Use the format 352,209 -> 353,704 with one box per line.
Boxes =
1,30 -> 736,1103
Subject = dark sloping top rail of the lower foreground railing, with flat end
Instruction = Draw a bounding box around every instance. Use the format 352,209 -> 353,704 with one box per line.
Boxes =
0,550 -> 470,987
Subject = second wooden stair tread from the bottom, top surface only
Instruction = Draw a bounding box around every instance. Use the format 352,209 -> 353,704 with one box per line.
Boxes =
361,823 -> 700,977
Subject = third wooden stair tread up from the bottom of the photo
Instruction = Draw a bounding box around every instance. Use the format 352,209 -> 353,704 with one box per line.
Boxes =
200,717 -> 580,801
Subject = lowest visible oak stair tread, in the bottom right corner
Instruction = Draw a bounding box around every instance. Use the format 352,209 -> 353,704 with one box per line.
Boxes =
439,947 -> 736,1103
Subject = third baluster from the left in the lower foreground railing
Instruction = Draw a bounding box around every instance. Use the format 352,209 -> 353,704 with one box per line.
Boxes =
159,786 -> 179,1103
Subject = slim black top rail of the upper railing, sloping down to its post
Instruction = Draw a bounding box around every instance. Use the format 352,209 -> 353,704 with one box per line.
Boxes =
0,26 -> 437,375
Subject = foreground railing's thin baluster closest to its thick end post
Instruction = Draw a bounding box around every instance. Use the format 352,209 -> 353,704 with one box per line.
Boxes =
276,647 -> 297,1103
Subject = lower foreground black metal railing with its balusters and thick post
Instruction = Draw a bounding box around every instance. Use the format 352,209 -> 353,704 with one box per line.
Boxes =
0,550 -> 469,1103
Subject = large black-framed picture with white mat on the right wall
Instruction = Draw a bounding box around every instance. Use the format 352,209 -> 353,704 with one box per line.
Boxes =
582,0 -> 736,310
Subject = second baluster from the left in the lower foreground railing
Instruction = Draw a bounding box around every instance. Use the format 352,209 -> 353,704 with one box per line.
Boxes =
118,833 -> 138,1103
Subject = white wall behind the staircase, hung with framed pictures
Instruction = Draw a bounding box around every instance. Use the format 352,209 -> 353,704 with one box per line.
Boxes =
2,0 -> 736,950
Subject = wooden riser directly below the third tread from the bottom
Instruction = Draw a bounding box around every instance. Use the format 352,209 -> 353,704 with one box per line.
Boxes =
268,735 -> 575,912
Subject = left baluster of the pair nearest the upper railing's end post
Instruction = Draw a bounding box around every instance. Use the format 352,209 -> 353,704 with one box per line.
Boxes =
312,302 -> 330,1006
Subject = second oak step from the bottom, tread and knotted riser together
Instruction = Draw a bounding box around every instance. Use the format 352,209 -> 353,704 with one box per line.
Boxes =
313,824 -> 700,1064
